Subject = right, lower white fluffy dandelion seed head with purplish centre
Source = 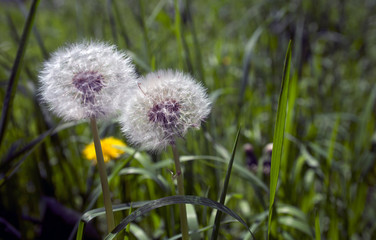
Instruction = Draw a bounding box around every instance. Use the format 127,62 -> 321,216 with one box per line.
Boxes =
120,70 -> 211,151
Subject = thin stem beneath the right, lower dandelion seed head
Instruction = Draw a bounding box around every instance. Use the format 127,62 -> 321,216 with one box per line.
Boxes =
171,144 -> 189,240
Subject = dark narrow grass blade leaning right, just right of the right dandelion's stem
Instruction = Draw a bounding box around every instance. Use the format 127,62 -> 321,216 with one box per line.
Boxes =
211,128 -> 240,239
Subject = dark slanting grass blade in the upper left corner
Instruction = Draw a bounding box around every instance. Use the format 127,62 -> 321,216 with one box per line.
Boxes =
0,0 -> 40,146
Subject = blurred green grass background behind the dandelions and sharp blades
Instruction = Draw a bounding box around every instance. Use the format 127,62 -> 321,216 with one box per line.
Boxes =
0,0 -> 376,240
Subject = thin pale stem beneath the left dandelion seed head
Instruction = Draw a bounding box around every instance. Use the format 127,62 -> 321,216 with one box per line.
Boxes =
90,118 -> 115,233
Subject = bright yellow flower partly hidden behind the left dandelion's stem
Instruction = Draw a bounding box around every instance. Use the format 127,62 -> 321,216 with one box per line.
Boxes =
82,137 -> 126,163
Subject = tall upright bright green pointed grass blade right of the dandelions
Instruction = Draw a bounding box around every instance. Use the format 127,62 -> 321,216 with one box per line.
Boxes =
268,41 -> 291,238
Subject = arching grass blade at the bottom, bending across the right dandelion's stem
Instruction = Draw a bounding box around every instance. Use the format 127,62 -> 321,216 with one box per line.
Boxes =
105,195 -> 251,240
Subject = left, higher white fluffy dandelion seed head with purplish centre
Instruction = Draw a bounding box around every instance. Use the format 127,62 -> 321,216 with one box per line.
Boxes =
39,42 -> 137,121
